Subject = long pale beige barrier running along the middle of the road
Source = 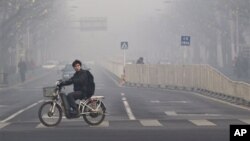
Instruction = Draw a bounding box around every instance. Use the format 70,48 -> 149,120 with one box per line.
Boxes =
105,61 -> 250,103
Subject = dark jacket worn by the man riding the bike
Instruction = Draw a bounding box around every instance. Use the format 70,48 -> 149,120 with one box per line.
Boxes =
61,69 -> 88,93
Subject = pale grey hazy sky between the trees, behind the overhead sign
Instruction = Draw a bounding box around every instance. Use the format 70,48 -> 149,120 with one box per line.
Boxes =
52,0 -> 167,62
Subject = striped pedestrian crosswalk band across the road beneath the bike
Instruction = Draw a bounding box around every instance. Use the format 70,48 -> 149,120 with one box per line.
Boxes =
0,119 -> 250,131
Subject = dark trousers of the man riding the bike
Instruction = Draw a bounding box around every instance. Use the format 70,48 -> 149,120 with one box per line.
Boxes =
67,91 -> 85,110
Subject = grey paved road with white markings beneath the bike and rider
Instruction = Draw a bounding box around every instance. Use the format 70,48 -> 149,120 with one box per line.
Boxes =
0,66 -> 250,141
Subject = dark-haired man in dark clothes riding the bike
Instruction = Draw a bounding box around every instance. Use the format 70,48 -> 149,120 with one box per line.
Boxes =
58,60 -> 93,115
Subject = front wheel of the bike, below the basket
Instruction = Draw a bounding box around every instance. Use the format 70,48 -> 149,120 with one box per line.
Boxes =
38,101 -> 62,127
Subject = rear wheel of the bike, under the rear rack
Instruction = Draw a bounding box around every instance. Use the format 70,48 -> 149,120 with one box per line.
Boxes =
83,100 -> 106,125
